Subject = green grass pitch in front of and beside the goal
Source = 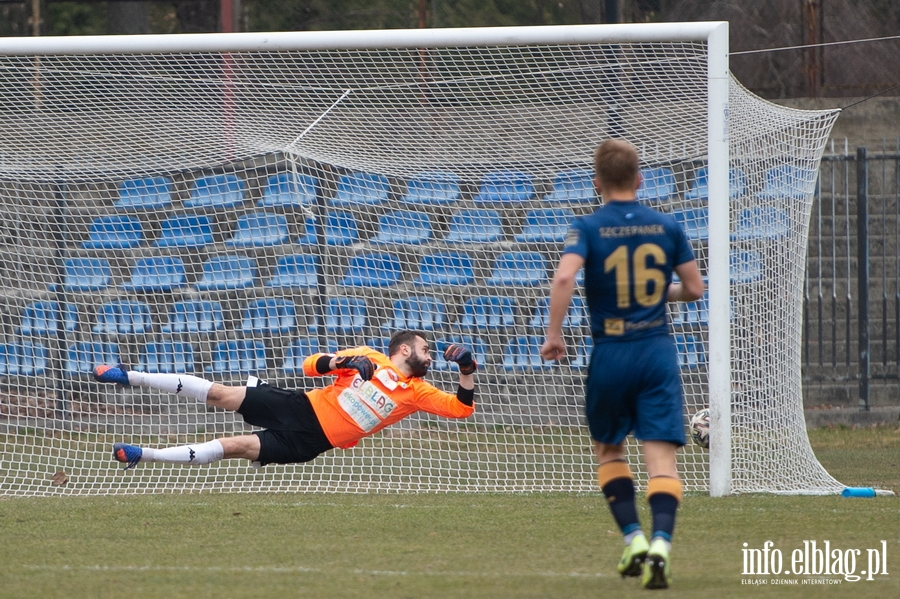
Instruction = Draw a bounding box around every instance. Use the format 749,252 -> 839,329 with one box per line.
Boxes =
0,426 -> 900,599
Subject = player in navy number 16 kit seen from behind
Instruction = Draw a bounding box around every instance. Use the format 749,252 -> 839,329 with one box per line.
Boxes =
541,139 -> 704,589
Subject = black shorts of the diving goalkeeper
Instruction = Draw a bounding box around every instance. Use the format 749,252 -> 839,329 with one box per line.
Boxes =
237,385 -> 334,466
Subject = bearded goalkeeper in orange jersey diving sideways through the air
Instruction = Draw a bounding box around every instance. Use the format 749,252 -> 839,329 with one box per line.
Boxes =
93,331 -> 478,470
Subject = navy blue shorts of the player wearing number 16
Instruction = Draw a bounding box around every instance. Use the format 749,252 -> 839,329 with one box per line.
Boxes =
585,335 -> 685,446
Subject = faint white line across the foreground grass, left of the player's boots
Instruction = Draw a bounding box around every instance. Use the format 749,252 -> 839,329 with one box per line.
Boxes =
22,564 -> 605,578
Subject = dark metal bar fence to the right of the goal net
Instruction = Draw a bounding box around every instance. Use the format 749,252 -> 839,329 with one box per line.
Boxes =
802,141 -> 900,410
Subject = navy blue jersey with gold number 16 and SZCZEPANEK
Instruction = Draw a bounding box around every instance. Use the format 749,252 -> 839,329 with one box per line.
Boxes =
563,201 -> 694,342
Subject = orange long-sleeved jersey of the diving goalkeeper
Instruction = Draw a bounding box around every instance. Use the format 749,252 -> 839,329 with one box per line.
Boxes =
303,347 -> 475,448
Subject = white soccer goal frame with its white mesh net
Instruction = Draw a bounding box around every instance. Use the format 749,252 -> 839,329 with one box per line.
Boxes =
0,23 -> 841,495
